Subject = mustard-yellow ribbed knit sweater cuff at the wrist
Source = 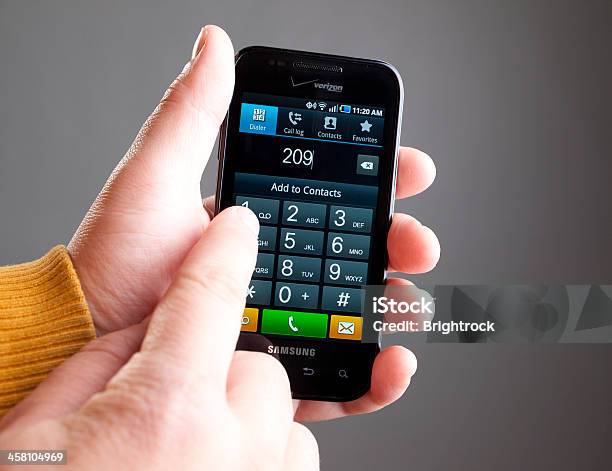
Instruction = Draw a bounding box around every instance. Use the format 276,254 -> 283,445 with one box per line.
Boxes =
0,246 -> 95,417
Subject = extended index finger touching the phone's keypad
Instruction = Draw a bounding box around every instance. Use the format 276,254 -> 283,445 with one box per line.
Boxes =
142,206 -> 259,389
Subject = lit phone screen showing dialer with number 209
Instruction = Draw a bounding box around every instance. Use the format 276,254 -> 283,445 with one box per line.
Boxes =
233,93 -> 385,342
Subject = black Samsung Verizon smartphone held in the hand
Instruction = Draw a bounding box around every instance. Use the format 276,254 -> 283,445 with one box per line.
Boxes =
216,46 -> 403,401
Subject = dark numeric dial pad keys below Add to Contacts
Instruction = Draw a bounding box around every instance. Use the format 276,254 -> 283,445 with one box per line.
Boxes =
241,195 -> 374,315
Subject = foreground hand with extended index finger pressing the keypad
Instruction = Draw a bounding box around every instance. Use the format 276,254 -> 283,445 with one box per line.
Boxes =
0,207 -> 318,471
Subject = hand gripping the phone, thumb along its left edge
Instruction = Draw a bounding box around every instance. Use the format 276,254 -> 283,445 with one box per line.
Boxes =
69,26 -> 440,420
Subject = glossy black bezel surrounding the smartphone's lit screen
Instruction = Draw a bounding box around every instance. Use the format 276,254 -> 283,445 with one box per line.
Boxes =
216,46 -> 403,401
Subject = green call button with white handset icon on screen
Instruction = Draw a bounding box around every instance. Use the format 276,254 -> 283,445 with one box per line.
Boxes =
261,309 -> 327,339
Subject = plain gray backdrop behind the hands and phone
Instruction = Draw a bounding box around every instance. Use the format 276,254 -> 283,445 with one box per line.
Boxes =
0,0 -> 612,470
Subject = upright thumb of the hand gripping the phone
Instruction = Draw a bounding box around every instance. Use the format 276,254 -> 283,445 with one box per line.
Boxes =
111,25 -> 234,195
